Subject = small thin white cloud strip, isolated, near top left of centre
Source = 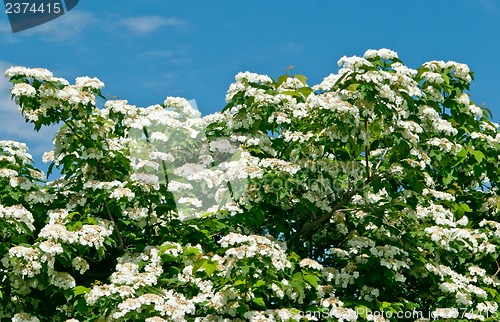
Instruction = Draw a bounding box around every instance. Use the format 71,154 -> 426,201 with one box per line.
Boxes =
119,16 -> 188,35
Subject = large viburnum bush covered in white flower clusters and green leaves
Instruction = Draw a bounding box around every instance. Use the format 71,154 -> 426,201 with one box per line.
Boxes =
0,49 -> 500,322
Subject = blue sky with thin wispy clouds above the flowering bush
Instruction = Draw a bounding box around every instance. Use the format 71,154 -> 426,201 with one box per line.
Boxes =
0,0 -> 500,174
